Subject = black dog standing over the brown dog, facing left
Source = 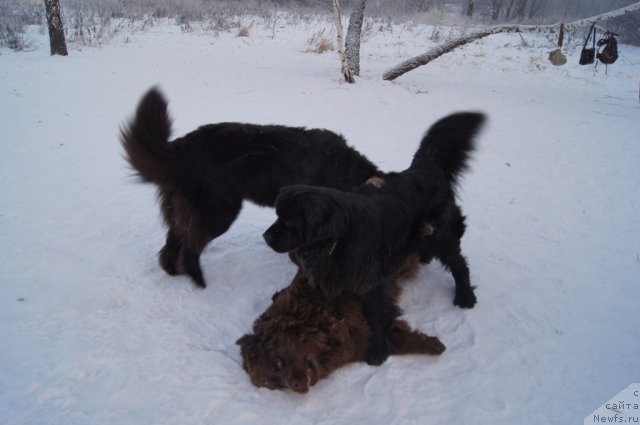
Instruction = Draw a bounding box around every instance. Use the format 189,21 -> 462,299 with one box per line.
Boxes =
264,113 -> 485,364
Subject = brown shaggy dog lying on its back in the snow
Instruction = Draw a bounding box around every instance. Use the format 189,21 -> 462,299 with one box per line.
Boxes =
236,256 -> 445,393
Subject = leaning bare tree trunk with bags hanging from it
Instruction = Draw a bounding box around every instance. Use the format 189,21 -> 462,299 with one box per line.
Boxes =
382,1 -> 640,80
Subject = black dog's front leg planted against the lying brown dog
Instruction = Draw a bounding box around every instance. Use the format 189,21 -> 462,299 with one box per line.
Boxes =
361,284 -> 401,366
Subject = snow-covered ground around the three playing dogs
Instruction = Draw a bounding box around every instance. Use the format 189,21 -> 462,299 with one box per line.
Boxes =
0,14 -> 640,425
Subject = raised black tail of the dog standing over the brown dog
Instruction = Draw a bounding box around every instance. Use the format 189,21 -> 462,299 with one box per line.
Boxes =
410,112 -> 486,185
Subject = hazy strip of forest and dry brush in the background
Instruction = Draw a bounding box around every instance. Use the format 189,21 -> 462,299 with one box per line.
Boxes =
0,0 -> 640,50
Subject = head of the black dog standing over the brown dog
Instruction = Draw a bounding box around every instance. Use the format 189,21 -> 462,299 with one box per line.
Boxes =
263,185 -> 349,252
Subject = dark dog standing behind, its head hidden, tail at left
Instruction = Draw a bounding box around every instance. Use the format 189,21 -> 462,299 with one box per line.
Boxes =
121,89 -> 379,287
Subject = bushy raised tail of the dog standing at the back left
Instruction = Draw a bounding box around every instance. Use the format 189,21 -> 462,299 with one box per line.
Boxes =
120,88 -> 175,184
